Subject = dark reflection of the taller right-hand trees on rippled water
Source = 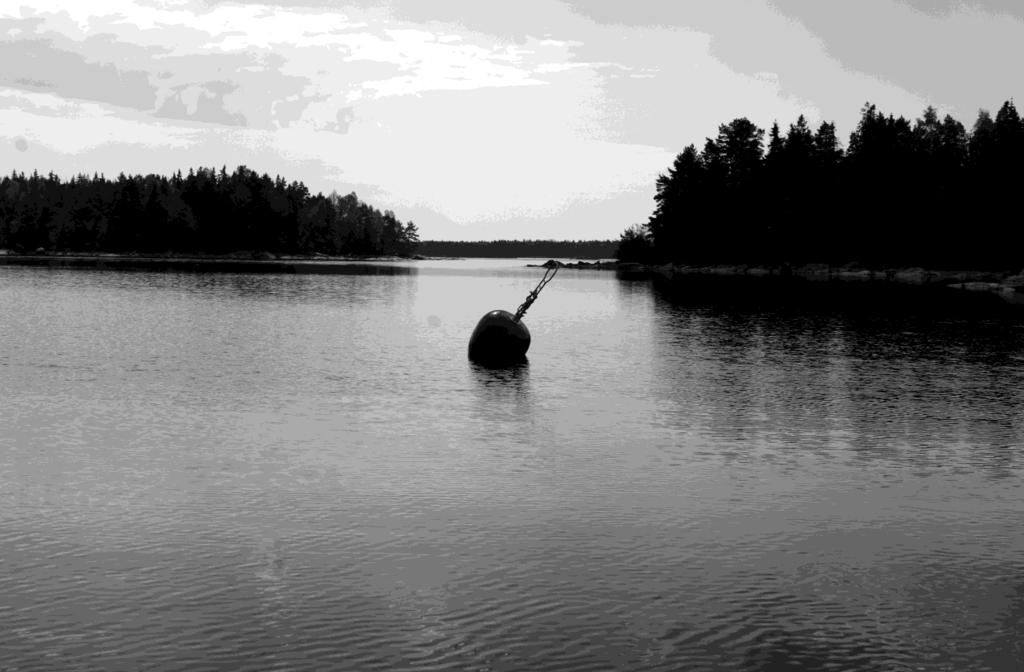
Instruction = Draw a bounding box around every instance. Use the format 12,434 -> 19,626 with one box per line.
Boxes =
652,278 -> 1024,476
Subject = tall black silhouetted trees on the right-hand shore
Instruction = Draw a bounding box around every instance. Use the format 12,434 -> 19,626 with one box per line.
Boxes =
617,101 -> 1024,270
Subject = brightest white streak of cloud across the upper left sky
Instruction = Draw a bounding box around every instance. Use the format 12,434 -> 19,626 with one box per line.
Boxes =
10,0 -> 560,102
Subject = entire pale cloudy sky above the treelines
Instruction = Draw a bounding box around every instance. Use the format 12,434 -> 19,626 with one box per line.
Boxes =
0,0 -> 1024,240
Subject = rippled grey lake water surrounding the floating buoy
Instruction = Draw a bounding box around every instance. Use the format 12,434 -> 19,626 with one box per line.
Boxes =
0,260 -> 1024,672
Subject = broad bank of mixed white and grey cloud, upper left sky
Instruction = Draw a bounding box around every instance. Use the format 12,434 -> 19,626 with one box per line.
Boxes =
0,0 -> 585,128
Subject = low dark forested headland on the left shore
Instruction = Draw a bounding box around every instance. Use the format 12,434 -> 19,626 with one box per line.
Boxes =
0,166 -> 419,255
